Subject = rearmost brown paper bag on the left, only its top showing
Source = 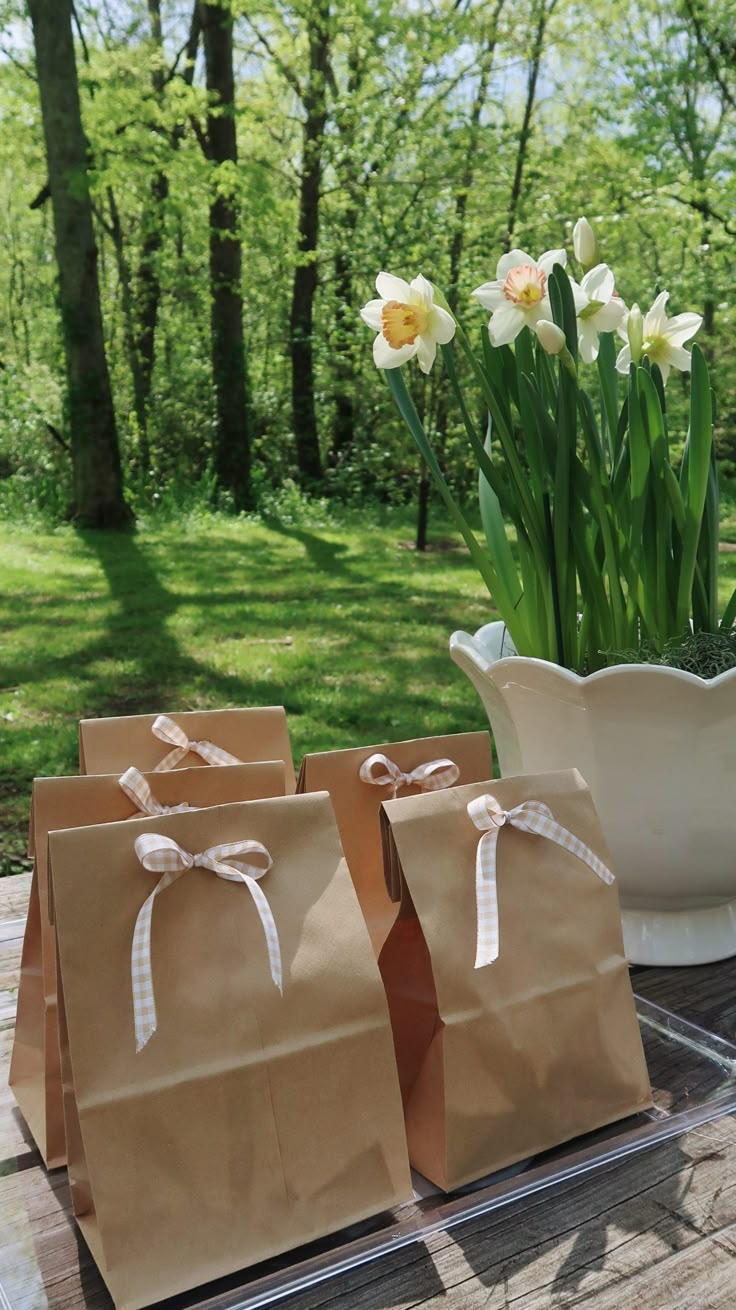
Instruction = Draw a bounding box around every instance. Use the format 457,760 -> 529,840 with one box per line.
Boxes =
80,705 -> 295,793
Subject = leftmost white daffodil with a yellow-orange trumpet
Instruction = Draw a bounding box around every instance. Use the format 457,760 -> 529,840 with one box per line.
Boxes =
360,272 -> 456,373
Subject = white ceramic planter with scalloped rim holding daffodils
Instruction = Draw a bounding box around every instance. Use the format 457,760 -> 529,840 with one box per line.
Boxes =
449,622 -> 736,964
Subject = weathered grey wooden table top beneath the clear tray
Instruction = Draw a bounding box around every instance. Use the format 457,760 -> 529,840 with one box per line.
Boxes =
0,875 -> 736,1310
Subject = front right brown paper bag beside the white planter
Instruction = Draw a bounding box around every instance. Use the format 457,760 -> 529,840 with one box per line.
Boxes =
378,770 -> 651,1189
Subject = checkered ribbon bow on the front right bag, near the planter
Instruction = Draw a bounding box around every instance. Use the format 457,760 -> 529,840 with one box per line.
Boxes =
468,795 -> 614,969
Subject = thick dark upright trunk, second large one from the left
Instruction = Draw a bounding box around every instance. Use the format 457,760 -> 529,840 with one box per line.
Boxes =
199,4 -> 253,508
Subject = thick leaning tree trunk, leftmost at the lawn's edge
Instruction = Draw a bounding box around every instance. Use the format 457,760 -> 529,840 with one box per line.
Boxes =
29,0 -> 131,528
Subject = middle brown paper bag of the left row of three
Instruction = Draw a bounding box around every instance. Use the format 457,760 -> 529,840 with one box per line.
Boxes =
8,760 -> 284,1169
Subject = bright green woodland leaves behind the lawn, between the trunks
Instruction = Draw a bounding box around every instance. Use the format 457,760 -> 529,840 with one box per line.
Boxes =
0,0 -> 736,515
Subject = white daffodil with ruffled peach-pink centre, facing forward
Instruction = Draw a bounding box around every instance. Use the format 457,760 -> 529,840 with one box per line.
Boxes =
473,250 -> 567,346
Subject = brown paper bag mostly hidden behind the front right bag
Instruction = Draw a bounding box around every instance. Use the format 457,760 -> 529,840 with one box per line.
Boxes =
296,732 -> 494,954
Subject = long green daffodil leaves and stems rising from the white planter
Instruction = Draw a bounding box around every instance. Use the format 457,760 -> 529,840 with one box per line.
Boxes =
386,290 -> 736,673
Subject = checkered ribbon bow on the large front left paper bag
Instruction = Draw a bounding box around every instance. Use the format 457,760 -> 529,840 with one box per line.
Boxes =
131,832 -> 283,1051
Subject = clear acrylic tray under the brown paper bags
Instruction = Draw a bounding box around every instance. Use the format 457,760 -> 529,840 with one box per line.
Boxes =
0,979 -> 736,1310
